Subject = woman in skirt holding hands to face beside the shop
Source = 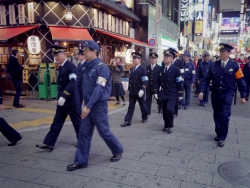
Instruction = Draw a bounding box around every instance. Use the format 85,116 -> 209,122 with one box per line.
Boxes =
110,57 -> 126,105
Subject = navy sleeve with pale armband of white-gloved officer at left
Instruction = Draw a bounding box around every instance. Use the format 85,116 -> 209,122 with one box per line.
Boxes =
61,65 -> 77,100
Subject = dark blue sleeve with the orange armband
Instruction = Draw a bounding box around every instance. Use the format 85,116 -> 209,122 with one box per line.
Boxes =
235,66 -> 247,98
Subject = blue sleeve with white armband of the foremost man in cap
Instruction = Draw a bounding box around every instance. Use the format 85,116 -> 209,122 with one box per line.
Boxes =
86,64 -> 111,109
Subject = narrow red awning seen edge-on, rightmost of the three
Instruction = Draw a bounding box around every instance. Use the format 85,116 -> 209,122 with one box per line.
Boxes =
96,30 -> 154,48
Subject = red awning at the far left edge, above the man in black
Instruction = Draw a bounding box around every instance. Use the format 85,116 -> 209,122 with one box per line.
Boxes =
0,26 -> 37,41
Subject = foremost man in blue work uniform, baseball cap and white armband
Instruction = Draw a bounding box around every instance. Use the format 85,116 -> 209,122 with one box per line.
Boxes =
67,41 -> 123,171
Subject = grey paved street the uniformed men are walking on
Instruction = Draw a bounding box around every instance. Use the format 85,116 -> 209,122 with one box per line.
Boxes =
0,96 -> 250,188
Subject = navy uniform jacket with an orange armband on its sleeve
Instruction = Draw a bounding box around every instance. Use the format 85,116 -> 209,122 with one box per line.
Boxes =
200,60 -> 247,98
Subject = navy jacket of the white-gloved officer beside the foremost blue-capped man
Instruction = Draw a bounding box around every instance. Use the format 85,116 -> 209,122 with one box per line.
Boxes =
57,60 -> 79,106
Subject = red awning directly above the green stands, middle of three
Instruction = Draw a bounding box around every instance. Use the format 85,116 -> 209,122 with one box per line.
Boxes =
49,26 -> 93,42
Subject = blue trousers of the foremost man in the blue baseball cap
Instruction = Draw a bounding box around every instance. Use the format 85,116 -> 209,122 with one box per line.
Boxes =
74,101 -> 123,165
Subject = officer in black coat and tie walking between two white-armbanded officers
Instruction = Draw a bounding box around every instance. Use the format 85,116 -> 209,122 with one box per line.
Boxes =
146,53 -> 161,115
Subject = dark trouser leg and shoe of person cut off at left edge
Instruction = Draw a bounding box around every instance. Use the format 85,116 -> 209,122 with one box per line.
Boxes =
0,89 -> 22,146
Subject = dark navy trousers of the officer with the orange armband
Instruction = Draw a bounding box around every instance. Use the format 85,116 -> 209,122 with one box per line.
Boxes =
211,92 -> 234,140
